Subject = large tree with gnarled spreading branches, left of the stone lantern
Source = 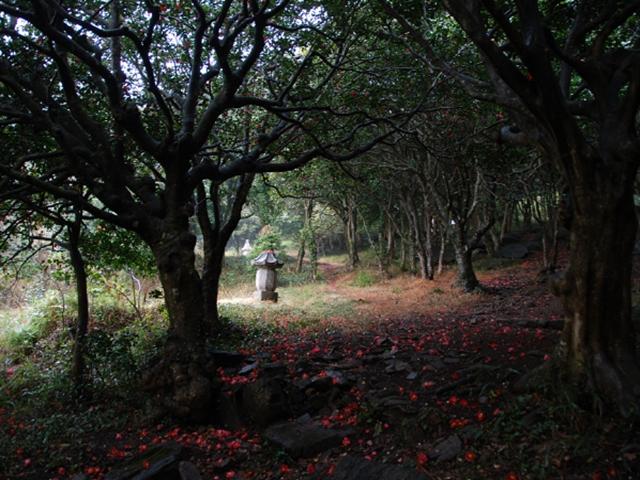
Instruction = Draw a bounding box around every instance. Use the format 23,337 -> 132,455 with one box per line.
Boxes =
0,0 -> 416,419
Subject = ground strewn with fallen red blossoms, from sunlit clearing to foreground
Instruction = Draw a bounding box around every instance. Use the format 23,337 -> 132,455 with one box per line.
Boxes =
0,251 -> 640,480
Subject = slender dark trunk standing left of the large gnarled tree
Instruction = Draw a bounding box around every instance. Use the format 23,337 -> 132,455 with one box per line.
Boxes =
67,212 -> 89,391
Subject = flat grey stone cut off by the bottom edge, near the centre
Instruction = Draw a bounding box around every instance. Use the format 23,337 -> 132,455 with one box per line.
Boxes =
313,456 -> 429,480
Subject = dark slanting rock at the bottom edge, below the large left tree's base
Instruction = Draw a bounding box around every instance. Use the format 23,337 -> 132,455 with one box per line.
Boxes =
105,443 -> 182,480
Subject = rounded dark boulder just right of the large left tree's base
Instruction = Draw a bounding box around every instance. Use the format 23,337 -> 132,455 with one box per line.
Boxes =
242,377 -> 290,426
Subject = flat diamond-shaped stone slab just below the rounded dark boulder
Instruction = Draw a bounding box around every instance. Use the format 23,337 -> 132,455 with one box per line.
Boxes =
264,417 -> 353,458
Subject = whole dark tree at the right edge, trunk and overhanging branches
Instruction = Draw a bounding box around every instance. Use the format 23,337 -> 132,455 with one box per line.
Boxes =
381,0 -> 640,413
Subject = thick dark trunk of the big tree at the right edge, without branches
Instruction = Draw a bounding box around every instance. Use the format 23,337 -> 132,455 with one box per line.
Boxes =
554,175 -> 640,414
